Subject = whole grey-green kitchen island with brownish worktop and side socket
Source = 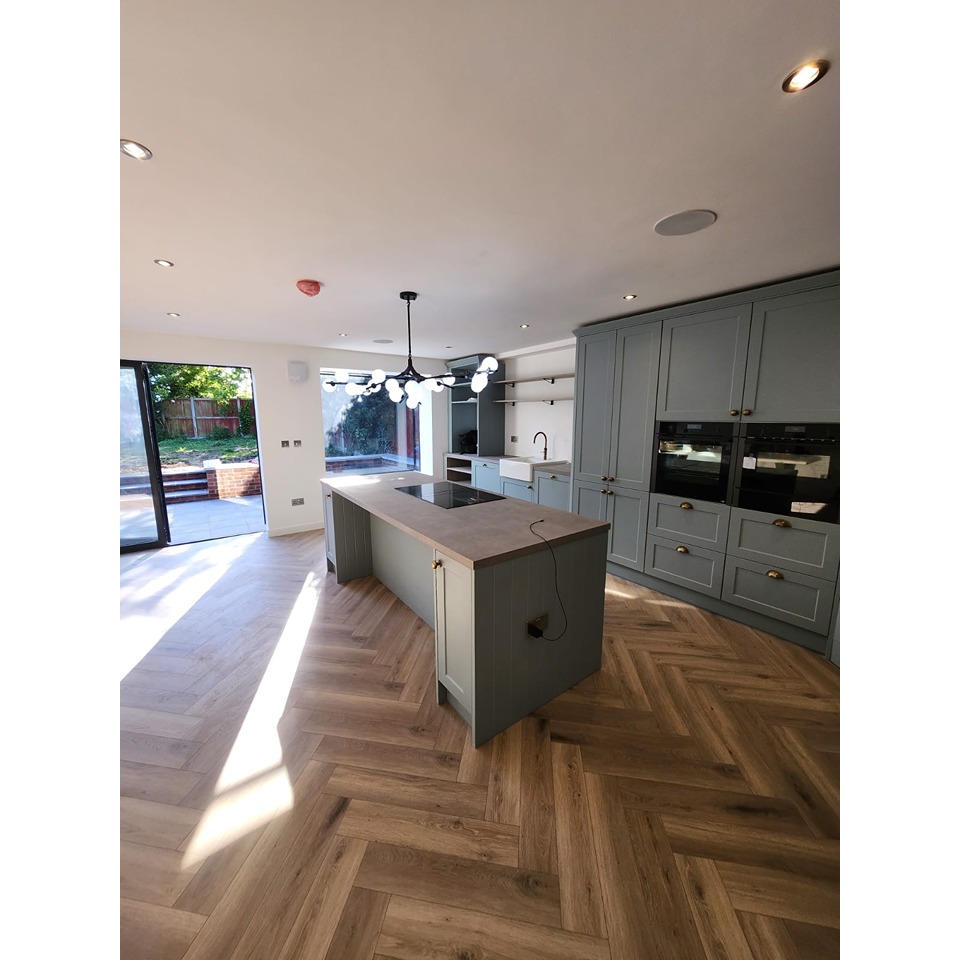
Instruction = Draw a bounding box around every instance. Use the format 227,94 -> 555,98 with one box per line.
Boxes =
323,473 -> 609,746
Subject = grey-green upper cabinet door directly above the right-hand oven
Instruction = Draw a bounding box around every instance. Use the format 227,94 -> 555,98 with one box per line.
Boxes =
743,286 -> 840,423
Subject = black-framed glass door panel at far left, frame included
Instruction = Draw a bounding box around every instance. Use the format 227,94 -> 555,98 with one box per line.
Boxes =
120,360 -> 170,552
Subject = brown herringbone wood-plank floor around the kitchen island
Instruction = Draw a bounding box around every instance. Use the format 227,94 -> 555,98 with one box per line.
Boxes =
120,534 -> 840,960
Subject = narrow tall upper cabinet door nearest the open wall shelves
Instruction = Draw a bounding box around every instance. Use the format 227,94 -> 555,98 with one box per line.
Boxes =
573,330 -> 617,483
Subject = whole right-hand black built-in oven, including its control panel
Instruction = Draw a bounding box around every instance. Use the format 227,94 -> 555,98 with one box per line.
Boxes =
734,423 -> 840,523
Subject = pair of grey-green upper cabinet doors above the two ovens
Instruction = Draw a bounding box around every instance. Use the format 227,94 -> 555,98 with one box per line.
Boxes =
656,286 -> 840,423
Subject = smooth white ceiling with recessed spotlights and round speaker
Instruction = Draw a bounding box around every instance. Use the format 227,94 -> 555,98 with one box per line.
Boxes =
120,0 -> 840,357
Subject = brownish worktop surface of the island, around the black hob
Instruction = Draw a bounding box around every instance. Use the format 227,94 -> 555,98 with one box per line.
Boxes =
322,473 -> 610,567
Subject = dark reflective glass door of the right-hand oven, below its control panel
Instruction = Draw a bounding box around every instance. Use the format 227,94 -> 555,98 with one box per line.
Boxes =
737,439 -> 840,523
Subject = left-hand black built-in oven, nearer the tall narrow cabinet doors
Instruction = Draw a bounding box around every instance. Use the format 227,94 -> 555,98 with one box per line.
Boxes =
653,420 -> 737,503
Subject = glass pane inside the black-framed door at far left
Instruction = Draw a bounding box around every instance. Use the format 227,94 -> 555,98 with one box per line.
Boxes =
120,367 -> 160,547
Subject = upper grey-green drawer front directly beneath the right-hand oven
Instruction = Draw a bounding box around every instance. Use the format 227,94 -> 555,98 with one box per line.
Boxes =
727,507 -> 840,580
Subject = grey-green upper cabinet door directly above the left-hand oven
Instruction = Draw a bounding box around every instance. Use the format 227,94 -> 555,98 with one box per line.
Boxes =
657,303 -> 751,420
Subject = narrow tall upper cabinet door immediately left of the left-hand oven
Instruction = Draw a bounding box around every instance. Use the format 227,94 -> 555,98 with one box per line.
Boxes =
609,323 -> 661,490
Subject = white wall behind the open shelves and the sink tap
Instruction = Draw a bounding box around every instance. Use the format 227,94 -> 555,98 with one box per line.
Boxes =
496,338 -> 576,460
